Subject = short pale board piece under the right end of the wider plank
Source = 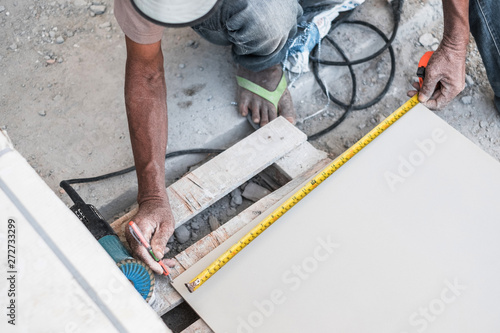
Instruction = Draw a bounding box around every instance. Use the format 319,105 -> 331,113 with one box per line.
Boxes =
275,141 -> 328,179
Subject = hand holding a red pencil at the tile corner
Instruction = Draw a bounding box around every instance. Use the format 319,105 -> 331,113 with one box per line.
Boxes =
125,198 -> 175,274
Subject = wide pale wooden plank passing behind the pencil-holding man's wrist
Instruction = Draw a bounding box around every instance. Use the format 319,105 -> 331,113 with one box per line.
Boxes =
111,117 -> 307,242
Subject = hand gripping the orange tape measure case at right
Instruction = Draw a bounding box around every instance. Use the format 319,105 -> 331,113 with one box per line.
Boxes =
408,41 -> 467,110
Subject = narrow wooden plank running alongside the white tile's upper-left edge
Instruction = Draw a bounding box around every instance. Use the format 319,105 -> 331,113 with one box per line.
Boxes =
152,159 -> 330,316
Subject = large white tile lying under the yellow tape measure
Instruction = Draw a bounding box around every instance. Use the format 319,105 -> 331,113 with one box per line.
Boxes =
174,105 -> 500,333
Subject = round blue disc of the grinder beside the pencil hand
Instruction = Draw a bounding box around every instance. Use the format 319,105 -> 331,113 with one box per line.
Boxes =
117,259 -> 155,302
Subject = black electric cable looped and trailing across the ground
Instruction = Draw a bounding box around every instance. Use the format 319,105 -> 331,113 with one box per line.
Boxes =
59,0 -> 403,203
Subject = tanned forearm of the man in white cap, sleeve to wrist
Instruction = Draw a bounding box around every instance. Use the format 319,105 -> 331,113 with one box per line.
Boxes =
125,49 -> 167,204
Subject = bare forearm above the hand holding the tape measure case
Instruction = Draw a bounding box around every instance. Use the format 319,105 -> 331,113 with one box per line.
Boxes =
443,0 -> 469,51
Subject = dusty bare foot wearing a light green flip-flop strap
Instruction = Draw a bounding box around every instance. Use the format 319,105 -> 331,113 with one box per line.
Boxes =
238,64 -> 295,126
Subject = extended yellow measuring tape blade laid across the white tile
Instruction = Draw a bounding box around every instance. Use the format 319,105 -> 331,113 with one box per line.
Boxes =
186,95 -> 418,292
